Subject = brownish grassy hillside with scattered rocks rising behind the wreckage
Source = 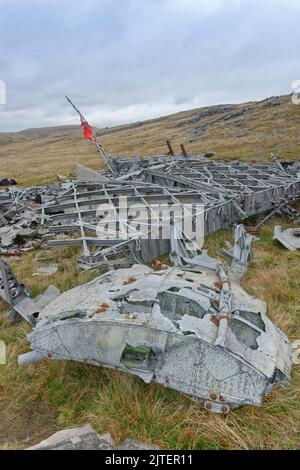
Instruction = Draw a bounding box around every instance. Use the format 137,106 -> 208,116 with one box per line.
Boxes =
0,96 -> 300,185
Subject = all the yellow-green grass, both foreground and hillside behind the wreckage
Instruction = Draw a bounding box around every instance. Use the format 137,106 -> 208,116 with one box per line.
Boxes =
0,97 -> 300,449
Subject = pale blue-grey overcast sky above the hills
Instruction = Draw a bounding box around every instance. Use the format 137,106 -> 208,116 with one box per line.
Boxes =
0,0 -> 300,132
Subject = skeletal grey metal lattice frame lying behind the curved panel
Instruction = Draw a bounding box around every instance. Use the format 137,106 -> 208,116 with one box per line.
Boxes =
36,155 -> 300,269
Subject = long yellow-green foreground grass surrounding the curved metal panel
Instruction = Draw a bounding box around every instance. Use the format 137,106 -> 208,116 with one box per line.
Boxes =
0,212 -> 300,449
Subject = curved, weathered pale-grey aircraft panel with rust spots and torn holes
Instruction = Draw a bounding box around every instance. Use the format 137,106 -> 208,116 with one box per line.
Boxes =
20,265 -> 291,413
